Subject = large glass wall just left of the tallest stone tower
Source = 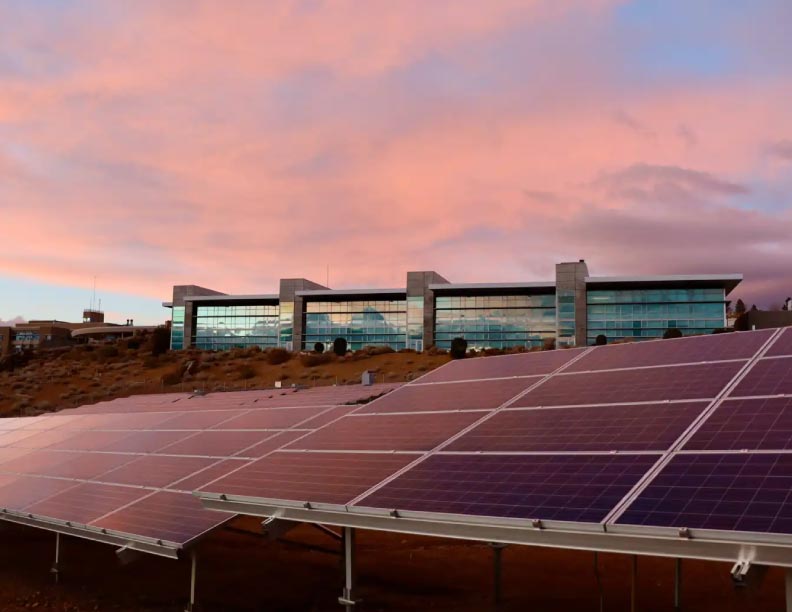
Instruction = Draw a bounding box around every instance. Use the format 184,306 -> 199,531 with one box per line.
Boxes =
435,294 -> 556,349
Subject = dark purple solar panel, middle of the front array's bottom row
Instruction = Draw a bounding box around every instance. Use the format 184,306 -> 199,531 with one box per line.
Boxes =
356,453 -> 659,522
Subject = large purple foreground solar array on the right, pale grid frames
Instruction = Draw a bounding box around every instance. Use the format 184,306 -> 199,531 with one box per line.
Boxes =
198,329 -> 792,534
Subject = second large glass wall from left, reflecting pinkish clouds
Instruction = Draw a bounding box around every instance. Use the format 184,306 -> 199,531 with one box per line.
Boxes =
303,299 -> 407,350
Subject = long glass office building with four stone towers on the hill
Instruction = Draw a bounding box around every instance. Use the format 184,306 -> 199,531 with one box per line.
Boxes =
165,261 -> 742,350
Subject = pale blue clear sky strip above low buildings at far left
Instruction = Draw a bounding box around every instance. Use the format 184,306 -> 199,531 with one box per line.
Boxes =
0,276 -> 170,325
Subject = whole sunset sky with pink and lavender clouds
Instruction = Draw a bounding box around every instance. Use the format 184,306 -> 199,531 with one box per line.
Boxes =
0,0 -> 792,323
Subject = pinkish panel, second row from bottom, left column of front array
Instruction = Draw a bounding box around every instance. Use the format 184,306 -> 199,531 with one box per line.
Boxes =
288,412 -> 482,451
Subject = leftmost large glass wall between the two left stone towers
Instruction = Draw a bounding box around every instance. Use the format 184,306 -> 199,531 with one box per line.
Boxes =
192,304 -> 279,350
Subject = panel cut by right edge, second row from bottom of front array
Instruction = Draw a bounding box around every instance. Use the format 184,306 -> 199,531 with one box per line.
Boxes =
684,397 -> 792,450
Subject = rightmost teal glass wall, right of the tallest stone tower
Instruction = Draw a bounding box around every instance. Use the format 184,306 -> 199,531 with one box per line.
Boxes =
586,289 -> 726,344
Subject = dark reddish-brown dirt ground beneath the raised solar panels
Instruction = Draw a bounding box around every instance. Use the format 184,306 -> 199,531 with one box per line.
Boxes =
0,518 -> 784,612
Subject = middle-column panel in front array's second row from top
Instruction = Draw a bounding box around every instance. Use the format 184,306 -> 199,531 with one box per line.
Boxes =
513,361 -> 745,407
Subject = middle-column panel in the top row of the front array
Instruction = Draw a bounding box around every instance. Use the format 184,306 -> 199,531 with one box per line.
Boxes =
565,329 -> 775,372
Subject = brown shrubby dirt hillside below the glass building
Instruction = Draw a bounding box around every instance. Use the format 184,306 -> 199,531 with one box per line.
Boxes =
0,343 -> 449,416
